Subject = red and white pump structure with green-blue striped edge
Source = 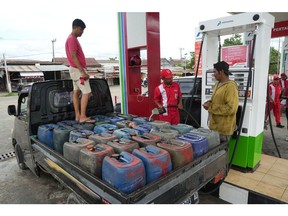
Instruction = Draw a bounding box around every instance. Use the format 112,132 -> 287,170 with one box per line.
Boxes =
118,12 -> 161,117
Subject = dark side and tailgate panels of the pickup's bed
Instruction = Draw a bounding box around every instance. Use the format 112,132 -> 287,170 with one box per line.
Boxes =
31,137 -> 228,204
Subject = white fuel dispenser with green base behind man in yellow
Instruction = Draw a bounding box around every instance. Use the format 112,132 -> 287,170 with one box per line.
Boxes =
199,13 -> 274,170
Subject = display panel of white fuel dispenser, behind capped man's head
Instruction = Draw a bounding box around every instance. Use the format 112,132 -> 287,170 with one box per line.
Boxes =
205,68 -> 254,99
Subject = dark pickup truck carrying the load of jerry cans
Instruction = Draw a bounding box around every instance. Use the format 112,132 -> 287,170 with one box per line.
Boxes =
8,79 -> 228,204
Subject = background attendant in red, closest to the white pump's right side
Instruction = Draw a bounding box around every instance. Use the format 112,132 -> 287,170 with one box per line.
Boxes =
266,75 -> 284,128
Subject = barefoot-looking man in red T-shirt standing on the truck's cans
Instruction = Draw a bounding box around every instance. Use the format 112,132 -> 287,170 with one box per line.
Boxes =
65,19 -> 95,123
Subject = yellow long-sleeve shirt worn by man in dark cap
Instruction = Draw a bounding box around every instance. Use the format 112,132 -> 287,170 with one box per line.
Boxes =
208,80 -> 239,136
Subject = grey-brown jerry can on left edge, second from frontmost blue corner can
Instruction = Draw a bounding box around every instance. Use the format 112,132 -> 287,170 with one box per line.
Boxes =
63,138 -> 95,164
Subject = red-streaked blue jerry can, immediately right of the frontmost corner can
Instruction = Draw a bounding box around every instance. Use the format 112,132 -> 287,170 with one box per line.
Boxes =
132,145 -> 172,184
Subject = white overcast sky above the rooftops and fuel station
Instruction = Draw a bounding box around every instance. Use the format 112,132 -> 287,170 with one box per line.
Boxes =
0,0 -> 286,61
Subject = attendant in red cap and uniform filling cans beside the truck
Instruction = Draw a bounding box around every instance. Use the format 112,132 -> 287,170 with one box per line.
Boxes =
154,69 -> 183,125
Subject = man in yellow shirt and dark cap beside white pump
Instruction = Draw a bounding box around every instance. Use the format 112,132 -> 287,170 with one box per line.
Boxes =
203,61 -> 239,142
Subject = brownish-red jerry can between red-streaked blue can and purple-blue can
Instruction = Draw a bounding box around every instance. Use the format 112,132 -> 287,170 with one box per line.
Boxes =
157,139 -> 193,169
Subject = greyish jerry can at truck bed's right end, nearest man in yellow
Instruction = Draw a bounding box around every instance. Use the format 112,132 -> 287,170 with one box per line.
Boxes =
189,128 -> 220,150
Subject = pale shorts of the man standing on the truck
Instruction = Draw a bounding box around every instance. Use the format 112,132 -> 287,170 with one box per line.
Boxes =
69,67 -> 91,94
